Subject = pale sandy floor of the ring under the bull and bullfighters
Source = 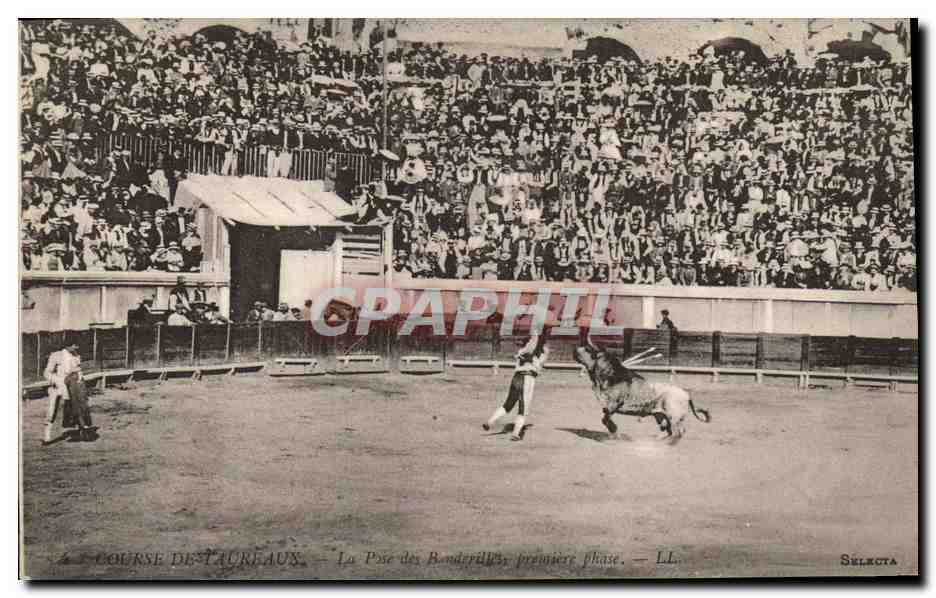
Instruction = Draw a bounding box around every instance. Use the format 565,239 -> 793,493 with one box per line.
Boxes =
21,372 -> 919,579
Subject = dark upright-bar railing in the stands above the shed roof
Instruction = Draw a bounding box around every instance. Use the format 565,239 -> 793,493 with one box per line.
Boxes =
95,133 -> 376,184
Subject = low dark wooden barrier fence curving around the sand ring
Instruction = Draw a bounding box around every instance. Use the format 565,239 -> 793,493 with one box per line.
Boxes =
20,321 -> 919,383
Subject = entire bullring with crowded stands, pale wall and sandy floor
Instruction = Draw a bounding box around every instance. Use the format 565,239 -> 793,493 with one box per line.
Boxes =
18,18 -> 920,580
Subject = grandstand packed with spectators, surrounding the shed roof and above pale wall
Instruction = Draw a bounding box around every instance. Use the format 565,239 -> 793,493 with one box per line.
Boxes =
20,20 -> 917,291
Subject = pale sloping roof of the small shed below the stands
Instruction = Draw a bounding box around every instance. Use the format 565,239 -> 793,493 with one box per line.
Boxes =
176,174 -> 356,226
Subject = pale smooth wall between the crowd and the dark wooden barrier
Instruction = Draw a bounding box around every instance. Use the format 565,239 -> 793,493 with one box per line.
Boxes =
20,272 -> 919,339
